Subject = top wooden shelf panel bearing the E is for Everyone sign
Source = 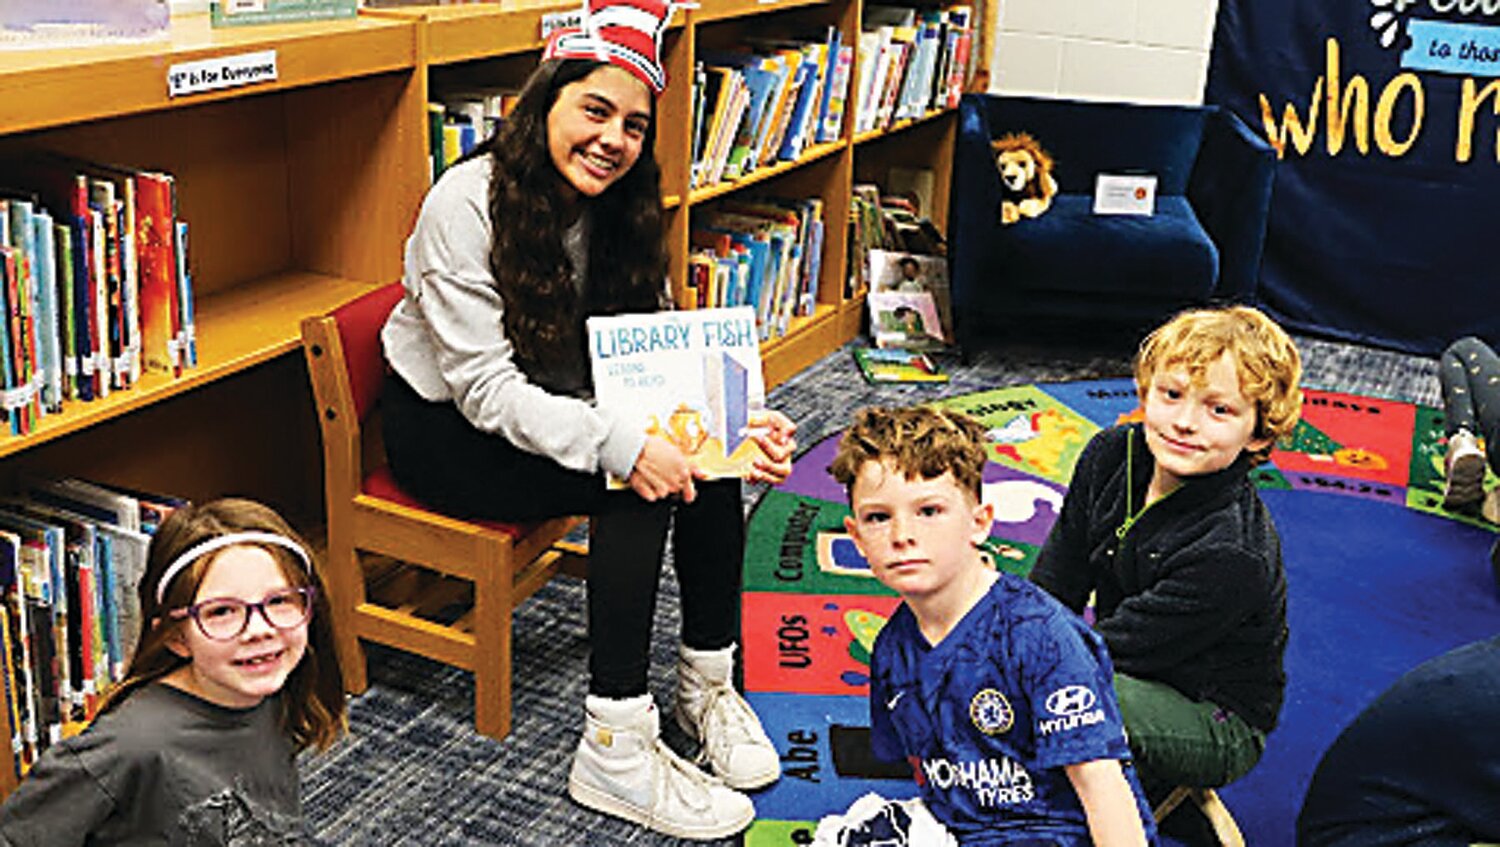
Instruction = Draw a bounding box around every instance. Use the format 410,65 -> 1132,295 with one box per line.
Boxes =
0,15 -> 417,135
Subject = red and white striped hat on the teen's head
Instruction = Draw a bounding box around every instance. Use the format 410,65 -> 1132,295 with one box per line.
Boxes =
542,0 -> 680,94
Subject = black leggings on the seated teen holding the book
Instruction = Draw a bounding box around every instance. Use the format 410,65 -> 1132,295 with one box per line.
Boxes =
381,375 -> 744,697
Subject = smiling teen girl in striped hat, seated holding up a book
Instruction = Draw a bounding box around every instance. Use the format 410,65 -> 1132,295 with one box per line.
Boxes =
381,0 -> 794,838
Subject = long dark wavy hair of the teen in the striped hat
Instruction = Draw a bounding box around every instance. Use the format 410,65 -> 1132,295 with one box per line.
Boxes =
476,58 -> 666,373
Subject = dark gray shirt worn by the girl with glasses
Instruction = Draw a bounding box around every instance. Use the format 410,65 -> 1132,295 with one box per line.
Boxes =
0,682 -> 302,847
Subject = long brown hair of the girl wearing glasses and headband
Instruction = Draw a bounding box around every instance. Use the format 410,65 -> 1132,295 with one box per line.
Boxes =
102,498 -> 348,750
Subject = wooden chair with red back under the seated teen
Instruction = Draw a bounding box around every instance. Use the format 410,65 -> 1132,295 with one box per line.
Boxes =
302,283 -> 582,739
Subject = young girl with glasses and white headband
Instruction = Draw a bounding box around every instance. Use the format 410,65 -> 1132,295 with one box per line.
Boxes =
0,499 -> 345,846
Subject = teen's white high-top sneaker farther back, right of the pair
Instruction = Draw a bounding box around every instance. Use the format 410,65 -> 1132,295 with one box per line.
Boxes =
672,645 -> 782,790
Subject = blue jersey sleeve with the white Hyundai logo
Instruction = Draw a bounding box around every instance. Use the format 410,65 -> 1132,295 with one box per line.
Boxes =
1022,610 -> 1130,768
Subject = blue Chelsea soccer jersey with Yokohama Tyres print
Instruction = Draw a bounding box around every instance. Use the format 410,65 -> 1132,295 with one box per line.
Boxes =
870,574 -> 1155,844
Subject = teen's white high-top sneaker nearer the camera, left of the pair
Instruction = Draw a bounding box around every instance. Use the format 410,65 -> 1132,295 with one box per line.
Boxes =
567,694 -> 755,841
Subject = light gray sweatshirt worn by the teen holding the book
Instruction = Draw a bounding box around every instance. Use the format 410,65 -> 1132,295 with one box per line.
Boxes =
381,156 -> 645,478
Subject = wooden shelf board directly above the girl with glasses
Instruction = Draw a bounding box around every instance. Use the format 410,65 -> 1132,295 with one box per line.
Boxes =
0,271 -> 375,457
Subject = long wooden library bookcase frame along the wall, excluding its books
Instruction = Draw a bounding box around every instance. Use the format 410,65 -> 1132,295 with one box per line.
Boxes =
0,0 -> 995,795
